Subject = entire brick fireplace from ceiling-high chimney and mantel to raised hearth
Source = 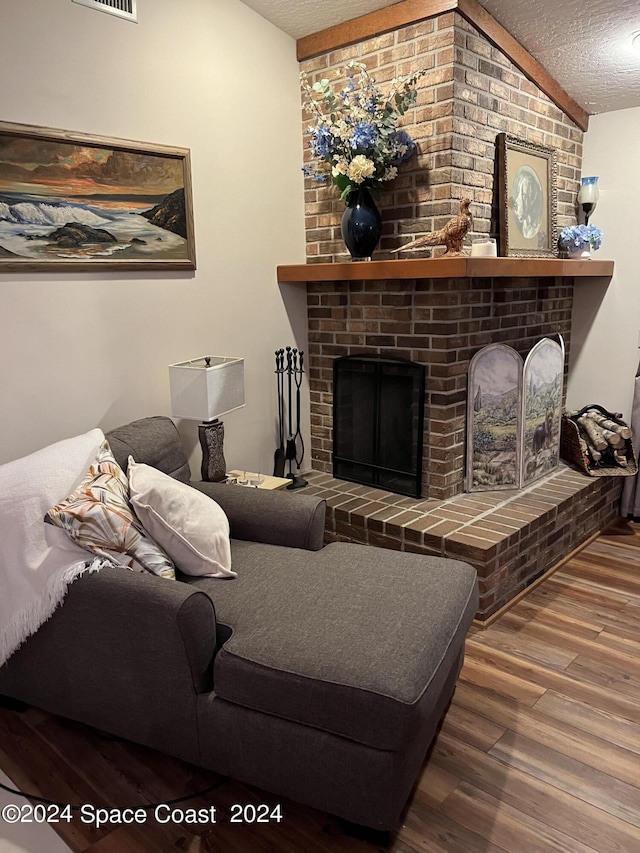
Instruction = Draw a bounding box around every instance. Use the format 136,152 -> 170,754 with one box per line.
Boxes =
278,0 -> 621,621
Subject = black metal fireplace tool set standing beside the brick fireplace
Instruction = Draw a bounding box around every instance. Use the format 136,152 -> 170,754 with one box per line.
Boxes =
273,347 -> 308,489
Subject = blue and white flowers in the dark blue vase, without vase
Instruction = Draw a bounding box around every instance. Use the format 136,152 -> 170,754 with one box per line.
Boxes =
300,60 -> 425,199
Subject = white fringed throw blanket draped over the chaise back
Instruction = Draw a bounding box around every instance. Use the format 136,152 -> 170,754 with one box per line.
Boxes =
0,429 -> 104,666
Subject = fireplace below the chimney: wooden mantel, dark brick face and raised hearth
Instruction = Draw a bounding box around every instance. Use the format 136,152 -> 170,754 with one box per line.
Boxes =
278,258 -> 621,621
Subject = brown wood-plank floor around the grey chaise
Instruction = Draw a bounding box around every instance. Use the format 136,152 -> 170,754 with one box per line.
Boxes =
0,524 -> 640,853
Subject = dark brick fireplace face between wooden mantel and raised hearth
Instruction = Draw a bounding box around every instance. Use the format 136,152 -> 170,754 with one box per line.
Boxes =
307,262 -> 573,500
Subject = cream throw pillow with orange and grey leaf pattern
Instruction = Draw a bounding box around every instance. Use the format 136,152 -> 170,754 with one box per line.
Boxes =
45,439 -> 175,578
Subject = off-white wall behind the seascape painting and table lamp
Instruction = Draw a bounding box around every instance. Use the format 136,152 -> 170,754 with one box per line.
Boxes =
0,0 -> 308,474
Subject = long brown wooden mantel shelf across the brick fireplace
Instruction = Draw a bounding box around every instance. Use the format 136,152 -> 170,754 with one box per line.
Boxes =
277,257 -> 613,284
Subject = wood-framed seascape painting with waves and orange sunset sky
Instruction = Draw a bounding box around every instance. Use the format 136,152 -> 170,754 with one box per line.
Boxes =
0,122 -> 196,272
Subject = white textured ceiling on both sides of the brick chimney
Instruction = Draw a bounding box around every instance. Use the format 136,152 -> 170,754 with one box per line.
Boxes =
243,0 -> 640,115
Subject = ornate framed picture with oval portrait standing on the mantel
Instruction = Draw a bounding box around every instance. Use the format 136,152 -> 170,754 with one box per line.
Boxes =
496,133 -> 558,258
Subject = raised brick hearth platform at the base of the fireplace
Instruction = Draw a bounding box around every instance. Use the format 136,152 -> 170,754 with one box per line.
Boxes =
304,464 -> 623,621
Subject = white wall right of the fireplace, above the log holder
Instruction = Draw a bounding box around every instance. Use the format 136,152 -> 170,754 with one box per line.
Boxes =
567,108 -> 640,420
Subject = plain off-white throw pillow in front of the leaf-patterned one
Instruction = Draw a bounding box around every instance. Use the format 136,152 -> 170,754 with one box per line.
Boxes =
127,456 -> 237,578
